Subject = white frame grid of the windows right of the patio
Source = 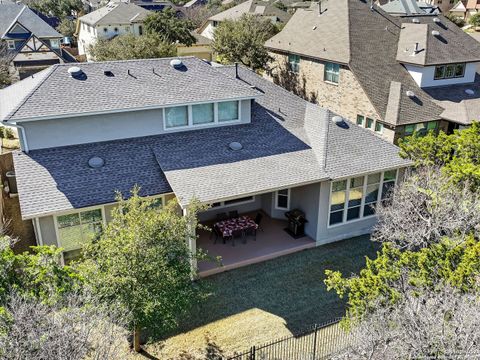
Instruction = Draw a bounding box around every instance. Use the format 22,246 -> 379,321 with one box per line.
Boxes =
327,168 -> 401,229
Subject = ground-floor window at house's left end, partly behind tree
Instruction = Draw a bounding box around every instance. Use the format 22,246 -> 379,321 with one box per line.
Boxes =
57,209 -> 103,252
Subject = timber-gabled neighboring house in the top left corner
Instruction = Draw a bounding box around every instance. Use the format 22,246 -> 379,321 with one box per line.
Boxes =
0,2 -> 75,79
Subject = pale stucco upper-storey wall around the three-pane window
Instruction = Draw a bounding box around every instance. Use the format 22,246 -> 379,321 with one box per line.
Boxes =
22,100 -> 251,150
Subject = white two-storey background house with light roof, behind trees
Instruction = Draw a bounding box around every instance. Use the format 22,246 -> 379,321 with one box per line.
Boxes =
78,2 -> 150,61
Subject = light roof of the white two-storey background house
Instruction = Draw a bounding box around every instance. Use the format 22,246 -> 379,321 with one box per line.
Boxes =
79,3 -> 150,26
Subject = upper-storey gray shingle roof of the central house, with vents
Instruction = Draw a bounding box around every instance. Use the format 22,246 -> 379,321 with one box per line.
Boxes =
0,57 -> 259,121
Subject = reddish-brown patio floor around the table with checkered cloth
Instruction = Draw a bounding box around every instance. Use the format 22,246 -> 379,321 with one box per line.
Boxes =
197,210 -> 315,277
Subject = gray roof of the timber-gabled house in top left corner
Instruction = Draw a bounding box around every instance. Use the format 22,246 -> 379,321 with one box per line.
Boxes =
0,2 -> 62,38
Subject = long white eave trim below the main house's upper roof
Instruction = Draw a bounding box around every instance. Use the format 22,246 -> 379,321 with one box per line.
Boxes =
7,94 -> 256,123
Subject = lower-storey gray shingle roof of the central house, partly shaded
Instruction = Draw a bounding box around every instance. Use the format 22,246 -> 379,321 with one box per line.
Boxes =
14,63 -> 409,218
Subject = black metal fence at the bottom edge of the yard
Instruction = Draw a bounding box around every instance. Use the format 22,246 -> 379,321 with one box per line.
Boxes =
227,319 -> 349,360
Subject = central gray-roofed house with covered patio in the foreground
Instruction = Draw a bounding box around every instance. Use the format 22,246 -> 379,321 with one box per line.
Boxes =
0,57 -> 410,270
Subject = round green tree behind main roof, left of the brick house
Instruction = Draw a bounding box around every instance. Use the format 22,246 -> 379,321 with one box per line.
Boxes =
212,14 -> 277,70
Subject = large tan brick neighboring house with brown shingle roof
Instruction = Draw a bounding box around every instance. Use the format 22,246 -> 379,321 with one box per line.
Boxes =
266,0 -> 480,142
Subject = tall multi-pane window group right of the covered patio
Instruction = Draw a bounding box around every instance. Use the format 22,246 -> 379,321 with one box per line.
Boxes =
328,170 -> 397,225
